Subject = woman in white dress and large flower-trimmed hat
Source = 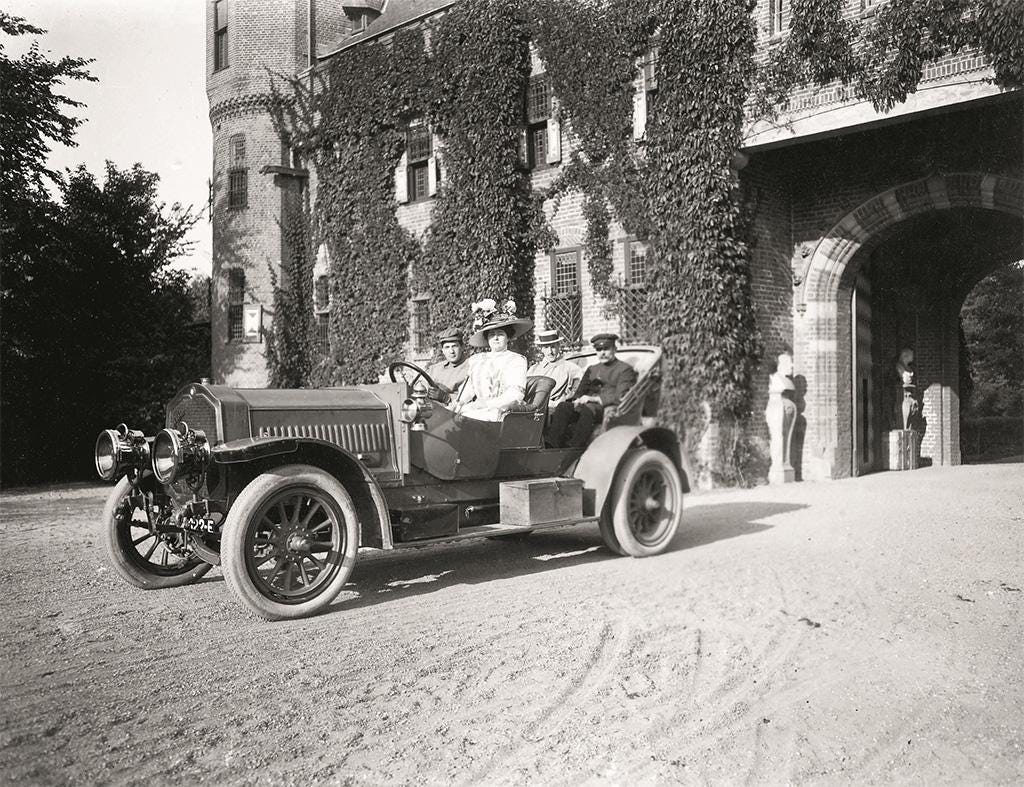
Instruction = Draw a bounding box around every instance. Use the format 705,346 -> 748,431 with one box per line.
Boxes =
453,317 -> 534,421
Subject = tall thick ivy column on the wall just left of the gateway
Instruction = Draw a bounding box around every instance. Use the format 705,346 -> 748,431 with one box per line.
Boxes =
644,0 -> 760,434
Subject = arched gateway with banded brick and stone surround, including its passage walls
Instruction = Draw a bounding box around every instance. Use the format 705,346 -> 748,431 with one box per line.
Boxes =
794,173 -> 1024,478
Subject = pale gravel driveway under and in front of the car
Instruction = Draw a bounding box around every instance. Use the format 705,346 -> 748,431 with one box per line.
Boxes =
0,464 -> 1024,785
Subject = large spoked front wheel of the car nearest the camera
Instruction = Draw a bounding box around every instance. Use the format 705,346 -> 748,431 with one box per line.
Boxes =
220,465 -> 359,620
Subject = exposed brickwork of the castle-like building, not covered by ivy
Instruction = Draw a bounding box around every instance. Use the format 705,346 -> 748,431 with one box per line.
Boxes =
207,0 -> 1024,479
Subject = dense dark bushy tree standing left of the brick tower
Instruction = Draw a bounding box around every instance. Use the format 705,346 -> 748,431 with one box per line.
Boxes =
0,164 -> 210,483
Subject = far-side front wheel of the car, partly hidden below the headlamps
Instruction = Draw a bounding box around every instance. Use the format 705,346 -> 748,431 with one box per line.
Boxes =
103,477 -> 211,591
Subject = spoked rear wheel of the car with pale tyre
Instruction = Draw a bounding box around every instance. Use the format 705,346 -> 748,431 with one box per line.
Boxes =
602,448 -> 683,558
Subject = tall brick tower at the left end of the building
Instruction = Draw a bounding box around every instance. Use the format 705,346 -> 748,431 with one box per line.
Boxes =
206,0 -> 340,387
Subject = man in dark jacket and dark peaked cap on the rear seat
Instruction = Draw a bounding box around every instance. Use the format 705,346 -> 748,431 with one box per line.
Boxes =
547,334 -> 637,448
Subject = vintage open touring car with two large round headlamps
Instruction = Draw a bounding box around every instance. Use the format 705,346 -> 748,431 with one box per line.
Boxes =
95,346 -> 689,620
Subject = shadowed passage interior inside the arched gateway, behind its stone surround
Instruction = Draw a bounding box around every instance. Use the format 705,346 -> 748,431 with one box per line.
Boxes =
850,207 -> 1024,475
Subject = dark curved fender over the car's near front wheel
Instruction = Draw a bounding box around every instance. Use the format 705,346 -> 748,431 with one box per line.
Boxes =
212,437 -> 394,550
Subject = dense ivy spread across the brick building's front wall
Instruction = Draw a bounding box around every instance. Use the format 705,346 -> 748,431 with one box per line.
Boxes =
262,0 -> 1024,479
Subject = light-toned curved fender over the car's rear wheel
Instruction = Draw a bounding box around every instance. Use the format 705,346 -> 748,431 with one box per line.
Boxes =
572,426 -> 690,517
